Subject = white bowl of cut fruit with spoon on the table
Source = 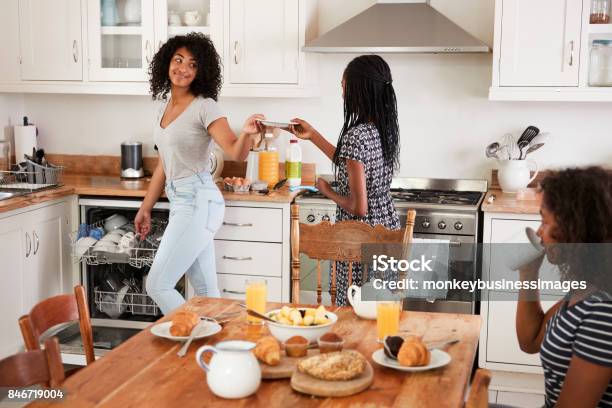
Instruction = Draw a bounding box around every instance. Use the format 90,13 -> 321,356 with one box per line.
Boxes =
266,305 -> 338,343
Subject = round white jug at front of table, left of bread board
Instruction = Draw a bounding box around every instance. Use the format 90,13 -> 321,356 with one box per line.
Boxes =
196,340 -> 261,398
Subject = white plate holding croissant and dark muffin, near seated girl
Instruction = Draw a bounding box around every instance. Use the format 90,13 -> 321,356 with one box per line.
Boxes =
372,336 -> 451,372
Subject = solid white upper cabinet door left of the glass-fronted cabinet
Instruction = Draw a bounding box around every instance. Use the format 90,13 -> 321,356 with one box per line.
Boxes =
17,0 -> 83,81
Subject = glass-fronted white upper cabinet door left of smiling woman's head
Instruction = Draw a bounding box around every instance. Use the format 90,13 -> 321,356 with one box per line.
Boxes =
87,0 -> 155,81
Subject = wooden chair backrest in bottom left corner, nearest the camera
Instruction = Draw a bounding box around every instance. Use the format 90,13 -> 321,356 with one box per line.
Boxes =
0,337 -> 64,387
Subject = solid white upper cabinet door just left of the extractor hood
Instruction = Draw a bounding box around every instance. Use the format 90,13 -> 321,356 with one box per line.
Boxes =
229,0 -> 299,84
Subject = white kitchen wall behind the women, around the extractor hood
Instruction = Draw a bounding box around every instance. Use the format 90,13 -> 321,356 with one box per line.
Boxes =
7,0 -> 612,178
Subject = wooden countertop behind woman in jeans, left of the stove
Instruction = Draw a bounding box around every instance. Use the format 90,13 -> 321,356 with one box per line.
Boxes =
0,175 -> 306,213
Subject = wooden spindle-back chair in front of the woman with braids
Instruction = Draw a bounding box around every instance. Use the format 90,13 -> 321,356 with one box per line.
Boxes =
291,204 -> 416,304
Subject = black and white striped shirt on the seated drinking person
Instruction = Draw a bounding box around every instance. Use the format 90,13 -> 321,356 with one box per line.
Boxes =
540,292 -> 612,408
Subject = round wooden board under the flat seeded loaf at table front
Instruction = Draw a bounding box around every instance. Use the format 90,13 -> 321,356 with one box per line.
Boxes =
291,361 -> 374,397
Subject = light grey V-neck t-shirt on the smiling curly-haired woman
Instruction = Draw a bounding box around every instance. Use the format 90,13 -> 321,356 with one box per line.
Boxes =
153,96 -> 225,180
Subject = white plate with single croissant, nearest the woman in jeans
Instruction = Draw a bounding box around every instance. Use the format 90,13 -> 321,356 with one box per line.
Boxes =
151,310 -> 221,341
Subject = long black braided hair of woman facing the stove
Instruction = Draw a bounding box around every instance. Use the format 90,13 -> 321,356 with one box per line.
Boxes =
333,55 -> 399,171
